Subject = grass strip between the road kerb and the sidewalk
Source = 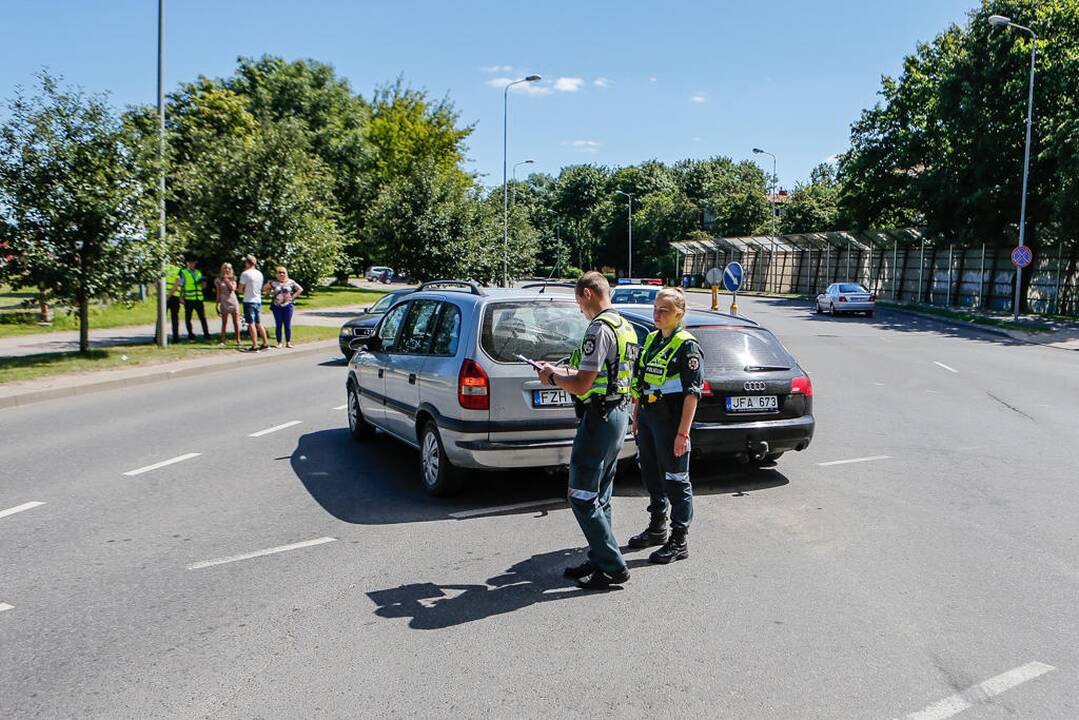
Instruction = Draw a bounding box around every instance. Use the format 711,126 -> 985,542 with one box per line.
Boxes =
0,325 -> 338,384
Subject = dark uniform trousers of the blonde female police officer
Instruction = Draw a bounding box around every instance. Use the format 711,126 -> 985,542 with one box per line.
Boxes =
637,398 -> 693,529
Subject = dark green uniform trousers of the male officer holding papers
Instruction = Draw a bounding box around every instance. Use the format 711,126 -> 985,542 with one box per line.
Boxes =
569,405 -> 629,573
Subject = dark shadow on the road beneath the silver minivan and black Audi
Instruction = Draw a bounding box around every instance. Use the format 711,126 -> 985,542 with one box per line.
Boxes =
288,427 -> 789,525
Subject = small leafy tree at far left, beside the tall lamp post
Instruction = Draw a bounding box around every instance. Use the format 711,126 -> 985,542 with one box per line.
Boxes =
0,73 -> 164,353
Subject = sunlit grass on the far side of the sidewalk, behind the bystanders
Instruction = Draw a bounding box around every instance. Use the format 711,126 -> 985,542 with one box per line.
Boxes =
0,285 -> 385,338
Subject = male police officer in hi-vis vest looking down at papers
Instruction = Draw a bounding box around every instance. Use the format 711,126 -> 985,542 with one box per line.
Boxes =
538,272 -> 638,589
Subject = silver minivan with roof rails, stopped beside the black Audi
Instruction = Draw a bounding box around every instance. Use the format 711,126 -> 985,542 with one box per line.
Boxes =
346,281 -> 636,494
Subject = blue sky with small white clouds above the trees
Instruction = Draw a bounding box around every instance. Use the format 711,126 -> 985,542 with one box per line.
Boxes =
0,0 -> 976,187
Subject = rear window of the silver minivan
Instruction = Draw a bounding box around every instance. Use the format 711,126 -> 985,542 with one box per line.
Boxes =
480,301 -> 588,363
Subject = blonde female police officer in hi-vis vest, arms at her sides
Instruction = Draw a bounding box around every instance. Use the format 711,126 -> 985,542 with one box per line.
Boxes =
629,287 -> 704,563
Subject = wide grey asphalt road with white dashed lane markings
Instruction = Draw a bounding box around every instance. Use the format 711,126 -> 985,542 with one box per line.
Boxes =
0,298 -> 1079,720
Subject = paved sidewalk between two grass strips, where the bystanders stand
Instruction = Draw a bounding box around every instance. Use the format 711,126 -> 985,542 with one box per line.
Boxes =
0,304 -> 367,357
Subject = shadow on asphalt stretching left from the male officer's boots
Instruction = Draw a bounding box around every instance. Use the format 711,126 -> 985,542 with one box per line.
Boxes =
367,548 -> 619,630
